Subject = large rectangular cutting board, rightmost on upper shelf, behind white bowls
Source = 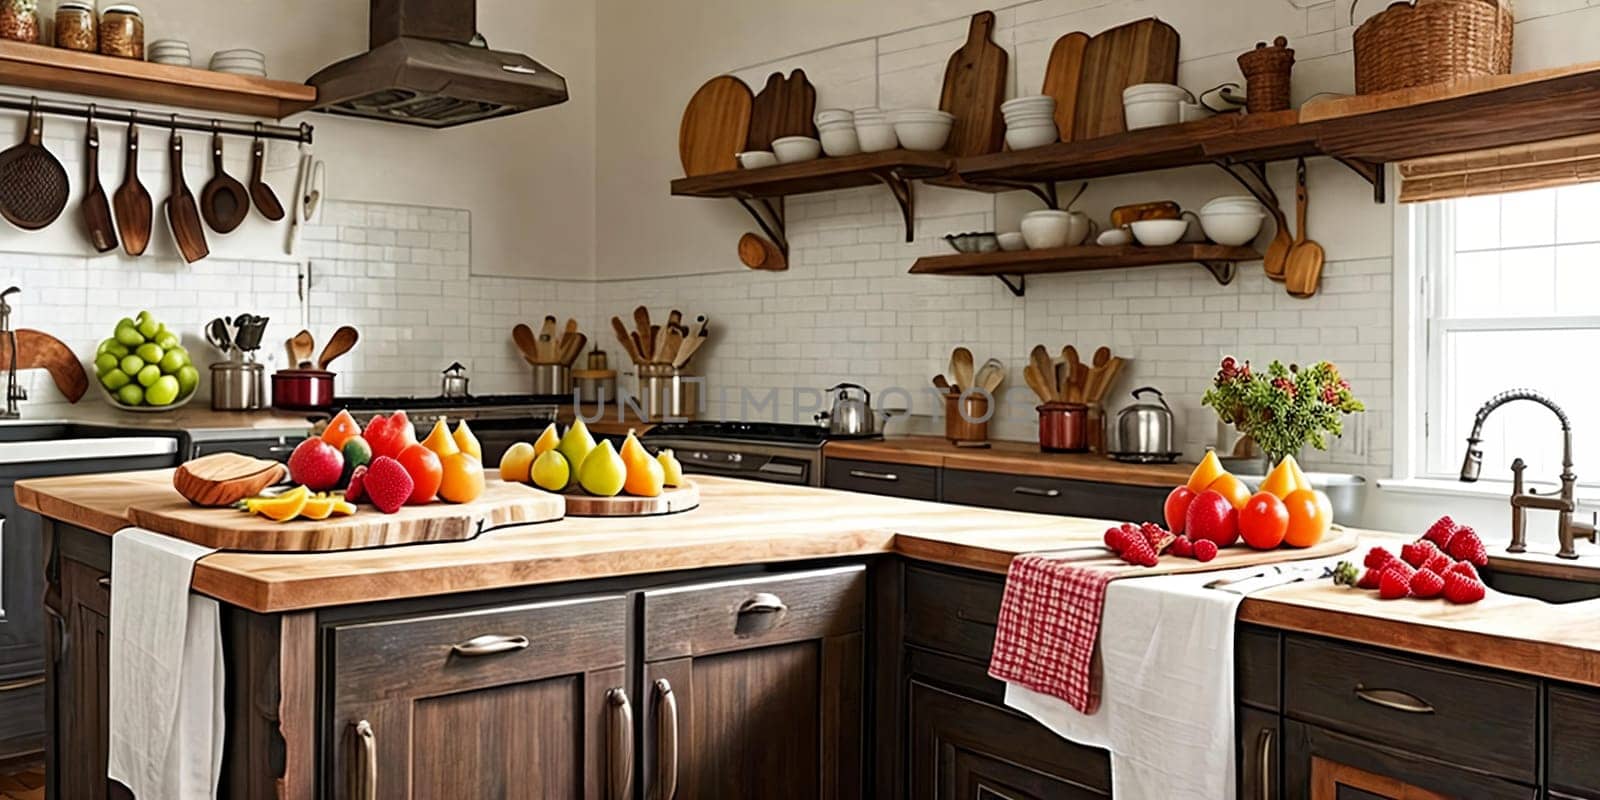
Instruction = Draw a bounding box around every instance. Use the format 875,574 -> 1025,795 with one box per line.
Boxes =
1072,16 -> 1178,141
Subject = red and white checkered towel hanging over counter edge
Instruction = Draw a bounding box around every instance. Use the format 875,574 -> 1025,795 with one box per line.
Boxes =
989,554 -> 1125,714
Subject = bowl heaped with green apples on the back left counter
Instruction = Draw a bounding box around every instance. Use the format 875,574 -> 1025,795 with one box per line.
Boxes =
94,310 -> 200,411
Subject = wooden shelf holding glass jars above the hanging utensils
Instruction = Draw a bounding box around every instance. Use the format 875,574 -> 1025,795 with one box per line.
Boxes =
0,40 -> 317,120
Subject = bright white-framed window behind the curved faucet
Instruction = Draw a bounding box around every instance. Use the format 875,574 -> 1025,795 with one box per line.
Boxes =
1411,184 -> 1600,485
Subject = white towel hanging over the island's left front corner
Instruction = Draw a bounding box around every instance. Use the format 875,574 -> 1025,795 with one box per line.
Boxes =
107,528 -> 224,800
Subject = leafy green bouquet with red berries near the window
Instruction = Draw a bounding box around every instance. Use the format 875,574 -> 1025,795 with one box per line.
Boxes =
1202,357 -> 1366,464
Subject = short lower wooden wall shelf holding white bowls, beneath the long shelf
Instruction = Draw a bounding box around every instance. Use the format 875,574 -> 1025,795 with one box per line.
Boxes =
910,243 -> 1261,296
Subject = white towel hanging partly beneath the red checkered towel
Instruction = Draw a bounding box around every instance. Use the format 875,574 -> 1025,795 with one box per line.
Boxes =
1005,562 -> 1331,800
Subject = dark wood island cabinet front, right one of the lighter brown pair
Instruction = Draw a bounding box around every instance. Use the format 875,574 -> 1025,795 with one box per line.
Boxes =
642,566 -> 866,800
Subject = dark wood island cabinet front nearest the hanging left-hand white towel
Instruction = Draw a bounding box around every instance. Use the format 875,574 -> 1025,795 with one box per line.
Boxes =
325,595 -> 634,800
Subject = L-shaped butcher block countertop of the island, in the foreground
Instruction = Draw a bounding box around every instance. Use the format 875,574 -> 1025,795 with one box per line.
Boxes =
16,470 -> 1600,686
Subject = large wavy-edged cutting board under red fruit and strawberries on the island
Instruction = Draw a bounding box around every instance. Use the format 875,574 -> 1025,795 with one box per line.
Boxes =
128,475 -> 566,552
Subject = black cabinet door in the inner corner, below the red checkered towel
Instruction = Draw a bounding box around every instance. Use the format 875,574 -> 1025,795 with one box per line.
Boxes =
907,680 -> 1110,800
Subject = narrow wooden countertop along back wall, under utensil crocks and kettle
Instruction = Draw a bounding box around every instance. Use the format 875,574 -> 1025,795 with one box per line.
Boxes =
822,437 -> 1194,488
